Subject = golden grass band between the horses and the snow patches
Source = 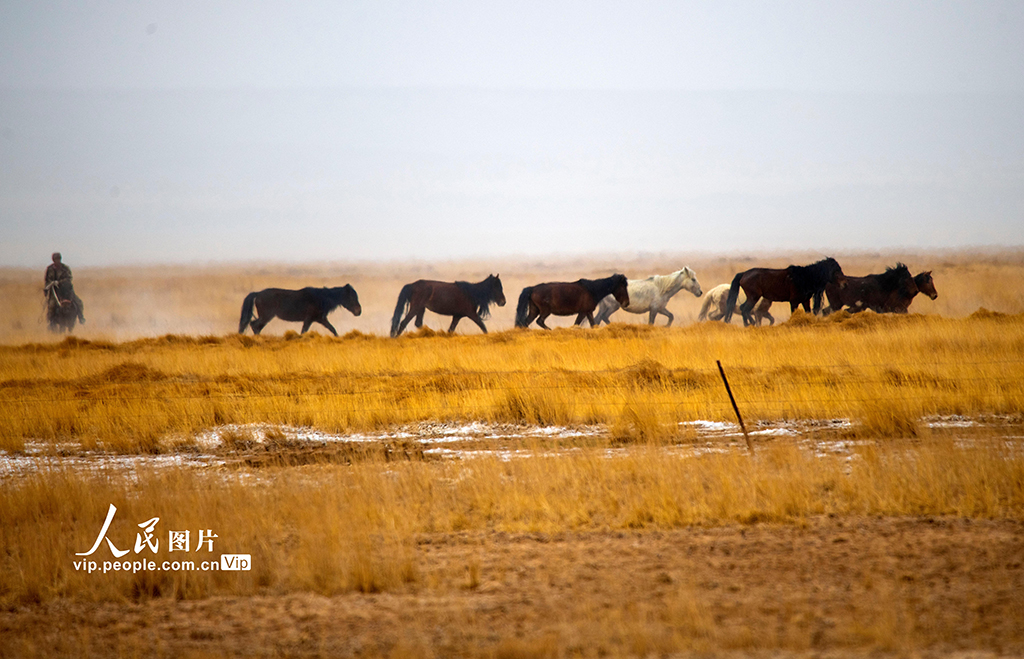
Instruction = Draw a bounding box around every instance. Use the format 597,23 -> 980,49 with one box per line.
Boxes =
0,312 -> 1024,452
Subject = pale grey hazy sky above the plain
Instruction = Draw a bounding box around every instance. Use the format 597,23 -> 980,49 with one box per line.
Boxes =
0,0 -> 1024,267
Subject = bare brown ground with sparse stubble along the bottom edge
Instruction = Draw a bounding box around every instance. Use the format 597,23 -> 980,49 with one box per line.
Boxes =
0,518 -> 1024,657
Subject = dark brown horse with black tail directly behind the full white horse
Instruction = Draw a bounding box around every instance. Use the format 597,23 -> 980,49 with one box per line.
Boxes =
515,274 -> 630,330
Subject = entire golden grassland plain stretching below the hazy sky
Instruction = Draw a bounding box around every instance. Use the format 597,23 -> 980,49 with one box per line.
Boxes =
0,253 -> 1024,657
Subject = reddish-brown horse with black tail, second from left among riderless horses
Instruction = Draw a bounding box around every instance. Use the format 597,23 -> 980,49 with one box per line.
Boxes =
391,274 -> 505,337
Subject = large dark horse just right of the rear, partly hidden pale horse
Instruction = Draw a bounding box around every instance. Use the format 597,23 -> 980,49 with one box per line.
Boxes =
722,257 -> 843,325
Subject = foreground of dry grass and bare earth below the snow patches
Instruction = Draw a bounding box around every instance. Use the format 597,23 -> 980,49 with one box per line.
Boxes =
0,438 -> 1024,657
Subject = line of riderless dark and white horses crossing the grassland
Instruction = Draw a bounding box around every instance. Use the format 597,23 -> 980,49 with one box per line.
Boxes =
239,258 -> 938,337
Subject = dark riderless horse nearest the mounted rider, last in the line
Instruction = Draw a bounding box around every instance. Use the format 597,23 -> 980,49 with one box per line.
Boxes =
239,283 -> 362,337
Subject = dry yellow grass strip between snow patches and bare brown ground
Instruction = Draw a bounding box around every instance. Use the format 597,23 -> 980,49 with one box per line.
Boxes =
0,441 -> 1024,606
